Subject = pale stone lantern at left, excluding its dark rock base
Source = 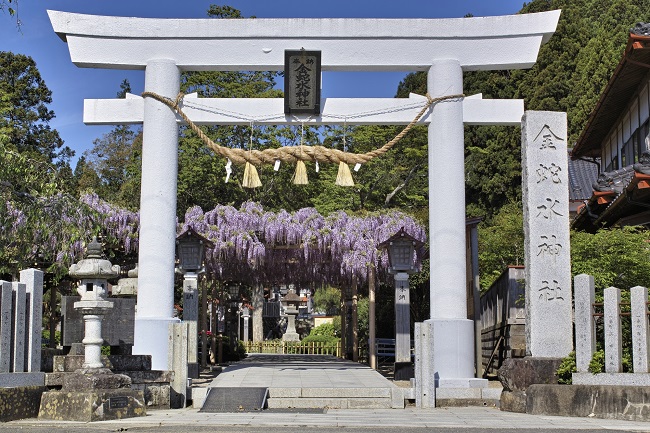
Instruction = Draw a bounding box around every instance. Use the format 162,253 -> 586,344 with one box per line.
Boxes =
69,238 -> 120,369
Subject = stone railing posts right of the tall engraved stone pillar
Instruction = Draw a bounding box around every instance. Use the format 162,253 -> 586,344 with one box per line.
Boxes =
573,274 -> 650,385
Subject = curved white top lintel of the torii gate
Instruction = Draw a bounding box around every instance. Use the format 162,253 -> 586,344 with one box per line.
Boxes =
48,10 -> 560,71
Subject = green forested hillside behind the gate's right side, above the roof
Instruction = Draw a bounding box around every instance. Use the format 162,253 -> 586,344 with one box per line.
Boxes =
397,0 -> 650,217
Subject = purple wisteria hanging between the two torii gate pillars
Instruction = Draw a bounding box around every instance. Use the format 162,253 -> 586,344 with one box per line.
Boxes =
179,202 -> 426,284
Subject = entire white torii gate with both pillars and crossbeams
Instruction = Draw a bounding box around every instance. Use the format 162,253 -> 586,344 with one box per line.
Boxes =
48,11 -> 560,387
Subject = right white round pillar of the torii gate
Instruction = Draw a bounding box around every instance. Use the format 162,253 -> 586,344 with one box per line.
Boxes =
427,59 -> 484,388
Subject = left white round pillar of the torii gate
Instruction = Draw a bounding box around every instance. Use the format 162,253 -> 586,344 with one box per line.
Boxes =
133,59 -> 180,370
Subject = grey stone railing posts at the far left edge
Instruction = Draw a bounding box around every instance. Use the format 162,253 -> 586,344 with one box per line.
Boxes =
0,269 -> 43,386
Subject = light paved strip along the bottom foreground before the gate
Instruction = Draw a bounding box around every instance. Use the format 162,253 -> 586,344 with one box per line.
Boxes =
5,407 -> 650,432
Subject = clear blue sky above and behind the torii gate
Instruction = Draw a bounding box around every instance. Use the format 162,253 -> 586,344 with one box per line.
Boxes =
0,0 -> 523,164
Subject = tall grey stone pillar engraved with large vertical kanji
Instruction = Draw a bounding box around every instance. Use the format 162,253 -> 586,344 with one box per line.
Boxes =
522,111 -> 573,358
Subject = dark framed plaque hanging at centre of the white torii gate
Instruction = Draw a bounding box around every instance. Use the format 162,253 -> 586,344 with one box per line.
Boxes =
284,49 -> 321,114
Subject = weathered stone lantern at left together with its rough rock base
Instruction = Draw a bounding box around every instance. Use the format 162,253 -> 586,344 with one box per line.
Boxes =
38,238 -> 146,422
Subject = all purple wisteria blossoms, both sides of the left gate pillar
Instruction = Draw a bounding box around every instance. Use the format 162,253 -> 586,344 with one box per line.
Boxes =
3,194 -> 426,284
